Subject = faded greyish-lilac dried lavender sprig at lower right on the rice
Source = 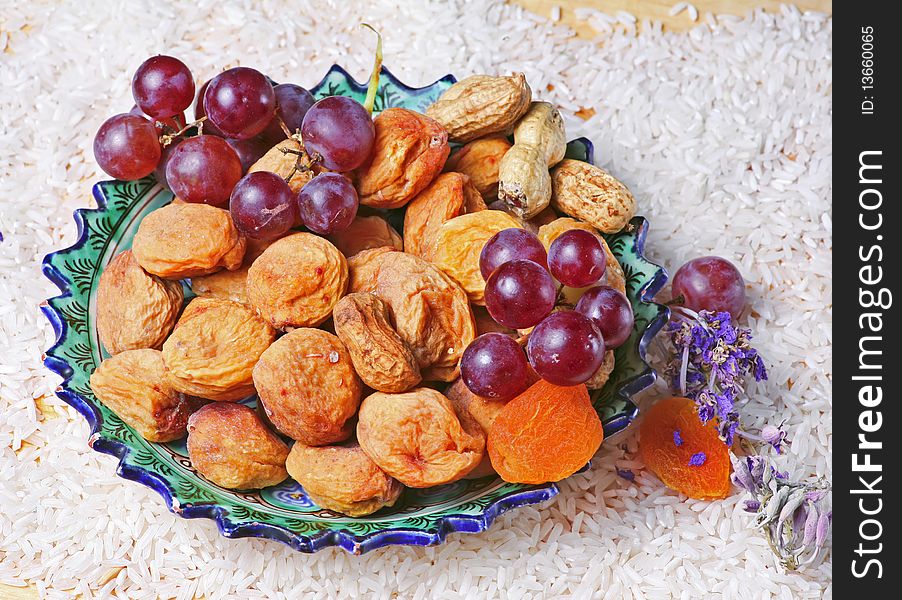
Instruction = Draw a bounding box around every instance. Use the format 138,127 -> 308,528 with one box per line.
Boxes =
732,456 -> 833,570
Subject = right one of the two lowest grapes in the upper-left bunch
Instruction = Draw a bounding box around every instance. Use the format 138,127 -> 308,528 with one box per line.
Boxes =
298,173 -> 359,235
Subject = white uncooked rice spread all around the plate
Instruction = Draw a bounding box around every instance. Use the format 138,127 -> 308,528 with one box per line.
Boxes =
0,0 -> 832,600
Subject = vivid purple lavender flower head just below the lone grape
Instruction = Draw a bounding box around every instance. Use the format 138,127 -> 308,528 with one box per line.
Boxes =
665,308 -> 768,445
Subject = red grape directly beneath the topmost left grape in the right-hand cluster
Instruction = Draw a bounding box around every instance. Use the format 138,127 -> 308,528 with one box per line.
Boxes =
488,260 -> 557,329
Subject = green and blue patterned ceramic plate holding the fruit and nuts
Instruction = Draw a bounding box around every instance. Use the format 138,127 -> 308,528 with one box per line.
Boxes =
43,66 -> 668,554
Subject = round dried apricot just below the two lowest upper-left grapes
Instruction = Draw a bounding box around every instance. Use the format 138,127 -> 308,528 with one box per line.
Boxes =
247,233 -> 348,329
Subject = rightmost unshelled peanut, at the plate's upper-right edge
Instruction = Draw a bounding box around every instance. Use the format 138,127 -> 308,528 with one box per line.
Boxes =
551,159 -> 636,233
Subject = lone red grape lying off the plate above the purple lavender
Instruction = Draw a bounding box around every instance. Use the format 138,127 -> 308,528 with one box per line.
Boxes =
672,256 -> 745,317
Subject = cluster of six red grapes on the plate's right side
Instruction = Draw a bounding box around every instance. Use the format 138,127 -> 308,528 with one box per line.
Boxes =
460,229 -> 633,400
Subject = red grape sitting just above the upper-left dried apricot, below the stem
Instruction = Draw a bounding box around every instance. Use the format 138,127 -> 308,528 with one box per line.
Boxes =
166,135 -> 241,207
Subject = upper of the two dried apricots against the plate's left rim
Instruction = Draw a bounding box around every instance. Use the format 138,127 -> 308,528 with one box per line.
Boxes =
97,250 -> 184,354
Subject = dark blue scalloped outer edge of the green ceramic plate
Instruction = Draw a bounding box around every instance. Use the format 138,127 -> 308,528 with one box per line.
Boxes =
41,64 -> 669,554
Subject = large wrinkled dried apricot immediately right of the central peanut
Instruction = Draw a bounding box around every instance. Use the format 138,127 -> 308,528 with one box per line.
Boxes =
350,248 -> 476,381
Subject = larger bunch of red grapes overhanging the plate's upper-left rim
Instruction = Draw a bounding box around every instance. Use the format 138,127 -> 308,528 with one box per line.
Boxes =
94,56 -> 375,239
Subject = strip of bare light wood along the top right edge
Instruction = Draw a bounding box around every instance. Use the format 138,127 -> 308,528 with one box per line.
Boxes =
508,0 -> 833,38
